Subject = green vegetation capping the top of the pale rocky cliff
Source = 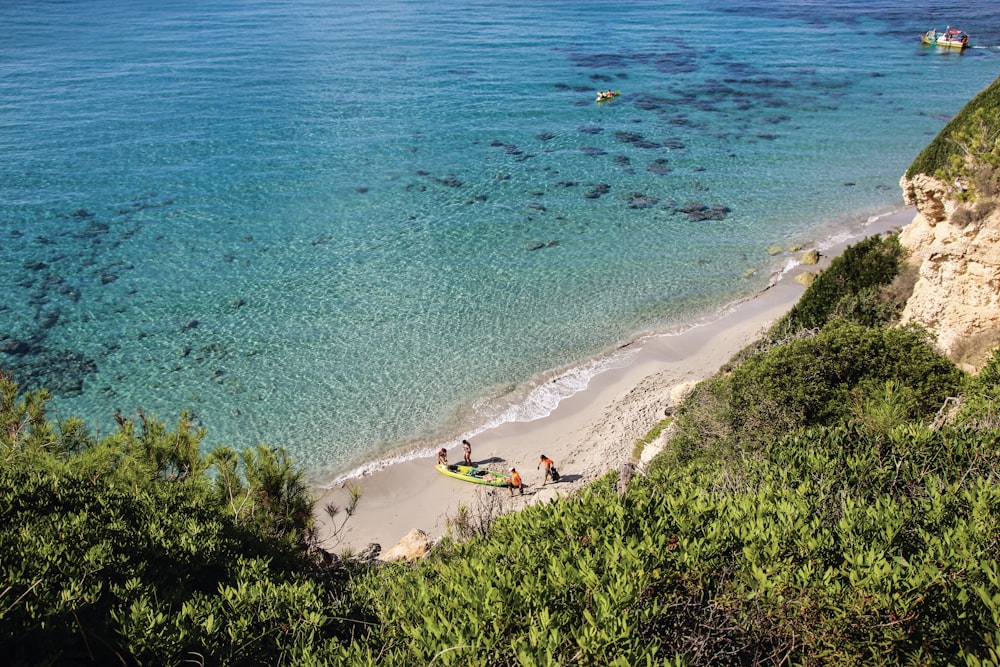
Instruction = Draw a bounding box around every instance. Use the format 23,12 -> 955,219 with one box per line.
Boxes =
906,79 -> 1000,199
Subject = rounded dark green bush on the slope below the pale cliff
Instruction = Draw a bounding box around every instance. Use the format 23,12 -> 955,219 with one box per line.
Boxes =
675,320 -> 963,460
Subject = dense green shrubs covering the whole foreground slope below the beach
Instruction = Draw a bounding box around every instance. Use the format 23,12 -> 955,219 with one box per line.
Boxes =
0,227 -> 1000,667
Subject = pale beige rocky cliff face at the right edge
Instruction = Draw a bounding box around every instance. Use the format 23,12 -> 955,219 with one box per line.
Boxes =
900,174 -> 1000,370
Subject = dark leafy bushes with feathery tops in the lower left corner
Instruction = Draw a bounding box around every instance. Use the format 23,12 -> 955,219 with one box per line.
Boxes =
0,373 -> 358,665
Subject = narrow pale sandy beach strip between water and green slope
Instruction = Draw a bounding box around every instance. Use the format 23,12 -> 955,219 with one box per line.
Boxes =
316,208 -> 915,554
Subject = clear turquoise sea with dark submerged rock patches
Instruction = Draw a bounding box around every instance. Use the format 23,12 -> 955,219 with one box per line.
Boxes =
0,0 -> 1000,479
